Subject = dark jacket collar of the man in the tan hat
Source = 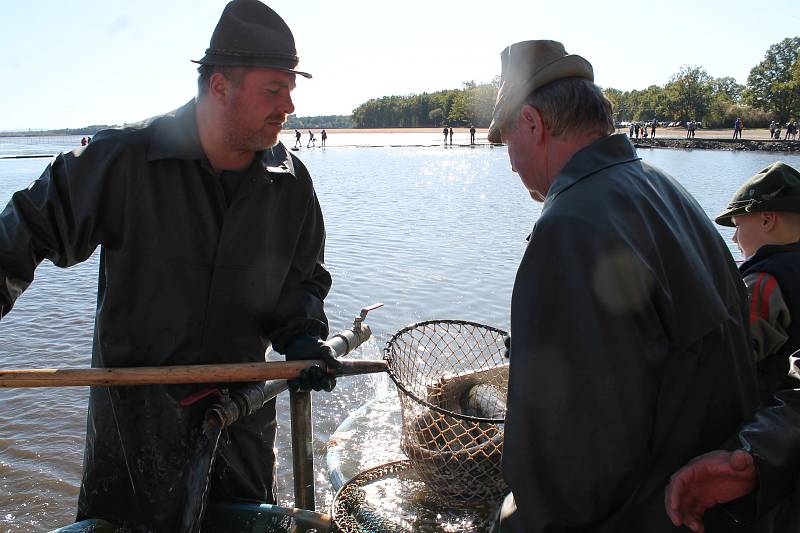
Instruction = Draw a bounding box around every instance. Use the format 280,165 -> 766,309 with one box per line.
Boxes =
544,133 -> 641,206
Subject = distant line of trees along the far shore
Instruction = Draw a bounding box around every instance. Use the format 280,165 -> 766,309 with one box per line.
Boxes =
9,37 -> 800,136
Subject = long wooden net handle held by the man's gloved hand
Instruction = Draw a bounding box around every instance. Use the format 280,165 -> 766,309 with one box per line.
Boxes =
0,359 -> 387,388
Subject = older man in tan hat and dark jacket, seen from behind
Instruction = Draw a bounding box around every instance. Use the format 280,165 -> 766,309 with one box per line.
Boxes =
489,41 -> 756,533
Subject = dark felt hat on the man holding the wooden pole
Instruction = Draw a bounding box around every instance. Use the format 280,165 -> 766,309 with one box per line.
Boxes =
194,0 -> 311,78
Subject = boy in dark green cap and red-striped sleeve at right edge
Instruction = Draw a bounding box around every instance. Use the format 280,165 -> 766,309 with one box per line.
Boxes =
716,161 -> 800,405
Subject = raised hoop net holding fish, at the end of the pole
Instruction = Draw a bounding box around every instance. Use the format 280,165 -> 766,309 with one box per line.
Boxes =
384,320 -> 508,506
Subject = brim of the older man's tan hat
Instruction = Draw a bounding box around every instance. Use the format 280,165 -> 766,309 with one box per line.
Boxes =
487,54 -> 594,144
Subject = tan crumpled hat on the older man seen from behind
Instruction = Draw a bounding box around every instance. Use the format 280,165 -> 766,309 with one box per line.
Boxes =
488,40 -> 594,143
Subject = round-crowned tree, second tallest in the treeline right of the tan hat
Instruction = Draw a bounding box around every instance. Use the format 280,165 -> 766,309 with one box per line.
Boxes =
664,66 -> 713,122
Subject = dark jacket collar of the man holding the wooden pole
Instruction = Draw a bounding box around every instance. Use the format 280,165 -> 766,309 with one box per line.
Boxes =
147,99 -> 297,177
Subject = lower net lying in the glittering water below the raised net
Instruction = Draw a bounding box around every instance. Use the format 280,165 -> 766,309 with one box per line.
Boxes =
331,461 -> 497,533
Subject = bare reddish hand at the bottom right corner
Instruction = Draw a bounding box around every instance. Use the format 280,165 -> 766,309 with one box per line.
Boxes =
664,450 -> 758,533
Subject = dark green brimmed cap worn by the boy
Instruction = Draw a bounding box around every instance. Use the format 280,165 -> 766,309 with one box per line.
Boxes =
714,161 -> 800,227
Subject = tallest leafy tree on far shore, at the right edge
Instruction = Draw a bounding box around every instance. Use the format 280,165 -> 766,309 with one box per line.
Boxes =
745,37 -> 800,120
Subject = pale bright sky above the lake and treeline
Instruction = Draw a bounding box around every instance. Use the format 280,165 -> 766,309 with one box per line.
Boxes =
0,0 -> 800,131
